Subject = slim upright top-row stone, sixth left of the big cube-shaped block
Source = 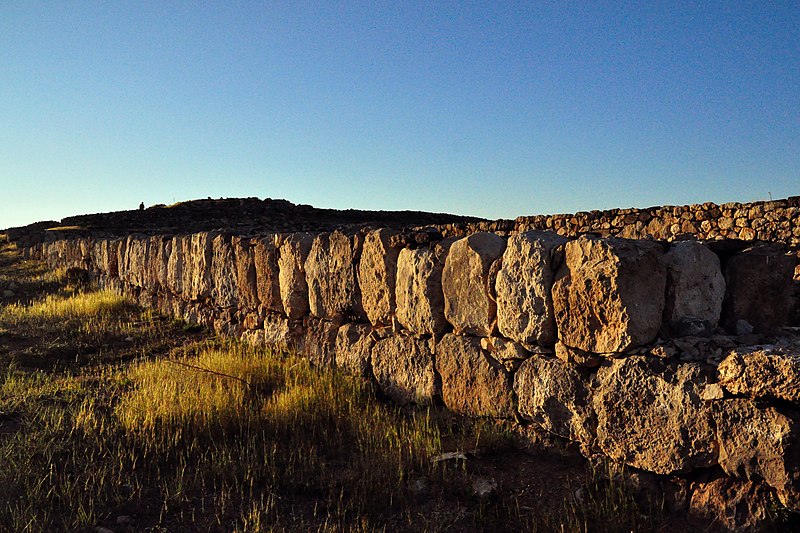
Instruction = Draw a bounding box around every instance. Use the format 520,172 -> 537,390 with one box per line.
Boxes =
278,233 -> 313,320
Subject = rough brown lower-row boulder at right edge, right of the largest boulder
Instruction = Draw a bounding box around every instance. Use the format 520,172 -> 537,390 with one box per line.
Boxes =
713,398 -> 800,509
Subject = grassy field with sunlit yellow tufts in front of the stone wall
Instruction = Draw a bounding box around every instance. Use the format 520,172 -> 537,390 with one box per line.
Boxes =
0,237 -> 764,532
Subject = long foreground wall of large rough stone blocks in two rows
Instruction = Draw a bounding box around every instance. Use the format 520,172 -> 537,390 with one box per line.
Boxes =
15,196 -> 800,510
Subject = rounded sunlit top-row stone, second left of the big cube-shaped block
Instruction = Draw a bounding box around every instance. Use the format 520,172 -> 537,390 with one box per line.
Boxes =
442,232 -> 506,337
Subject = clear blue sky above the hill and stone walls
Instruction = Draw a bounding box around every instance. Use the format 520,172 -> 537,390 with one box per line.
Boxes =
0,0 -> 800,228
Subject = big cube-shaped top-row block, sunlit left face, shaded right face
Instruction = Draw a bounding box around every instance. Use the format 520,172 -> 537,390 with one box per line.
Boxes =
553,236 -> 666,353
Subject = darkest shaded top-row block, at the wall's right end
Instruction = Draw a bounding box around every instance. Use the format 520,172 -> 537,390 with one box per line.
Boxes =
722,245 -> 797,333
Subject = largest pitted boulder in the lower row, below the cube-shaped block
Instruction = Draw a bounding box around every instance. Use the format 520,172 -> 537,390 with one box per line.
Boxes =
592,356 -> 717,474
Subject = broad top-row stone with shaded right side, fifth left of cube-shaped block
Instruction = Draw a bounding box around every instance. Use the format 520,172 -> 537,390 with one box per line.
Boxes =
306,231 -> 362,323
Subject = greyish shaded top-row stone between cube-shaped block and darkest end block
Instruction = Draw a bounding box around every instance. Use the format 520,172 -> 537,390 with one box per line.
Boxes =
664,241 -> 725,332
